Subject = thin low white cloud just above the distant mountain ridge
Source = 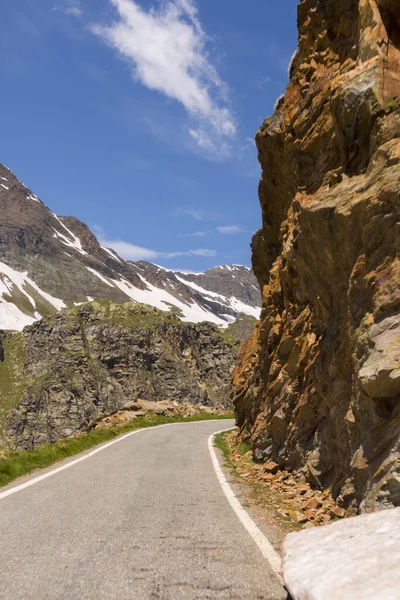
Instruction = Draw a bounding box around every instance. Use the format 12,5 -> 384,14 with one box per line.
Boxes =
93,225 -> 217,261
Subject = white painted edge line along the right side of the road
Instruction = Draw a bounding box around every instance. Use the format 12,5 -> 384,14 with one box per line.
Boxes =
208,427 -> 283,583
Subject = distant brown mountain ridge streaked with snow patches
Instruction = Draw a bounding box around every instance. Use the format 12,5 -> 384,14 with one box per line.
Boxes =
0,164 -> 261,330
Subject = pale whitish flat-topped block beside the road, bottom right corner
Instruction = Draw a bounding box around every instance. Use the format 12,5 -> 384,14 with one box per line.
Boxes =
283,508 -> 400,600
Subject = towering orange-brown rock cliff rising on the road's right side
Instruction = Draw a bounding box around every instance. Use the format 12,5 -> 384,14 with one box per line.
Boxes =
233,0 -> 400,511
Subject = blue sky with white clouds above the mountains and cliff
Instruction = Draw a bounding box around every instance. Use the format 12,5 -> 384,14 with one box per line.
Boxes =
0,0 -> 297,271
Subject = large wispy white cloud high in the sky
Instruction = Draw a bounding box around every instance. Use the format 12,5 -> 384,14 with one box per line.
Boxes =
91,0 -> 236,157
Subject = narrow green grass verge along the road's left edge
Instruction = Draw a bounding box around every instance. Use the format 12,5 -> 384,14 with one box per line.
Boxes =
0,414 -> 233,487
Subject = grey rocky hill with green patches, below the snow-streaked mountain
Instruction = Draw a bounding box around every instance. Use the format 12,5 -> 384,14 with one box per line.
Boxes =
0,302 -> 236,449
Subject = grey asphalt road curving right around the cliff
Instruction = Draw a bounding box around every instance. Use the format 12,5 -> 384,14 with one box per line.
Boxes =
0,421 -> 286,600
